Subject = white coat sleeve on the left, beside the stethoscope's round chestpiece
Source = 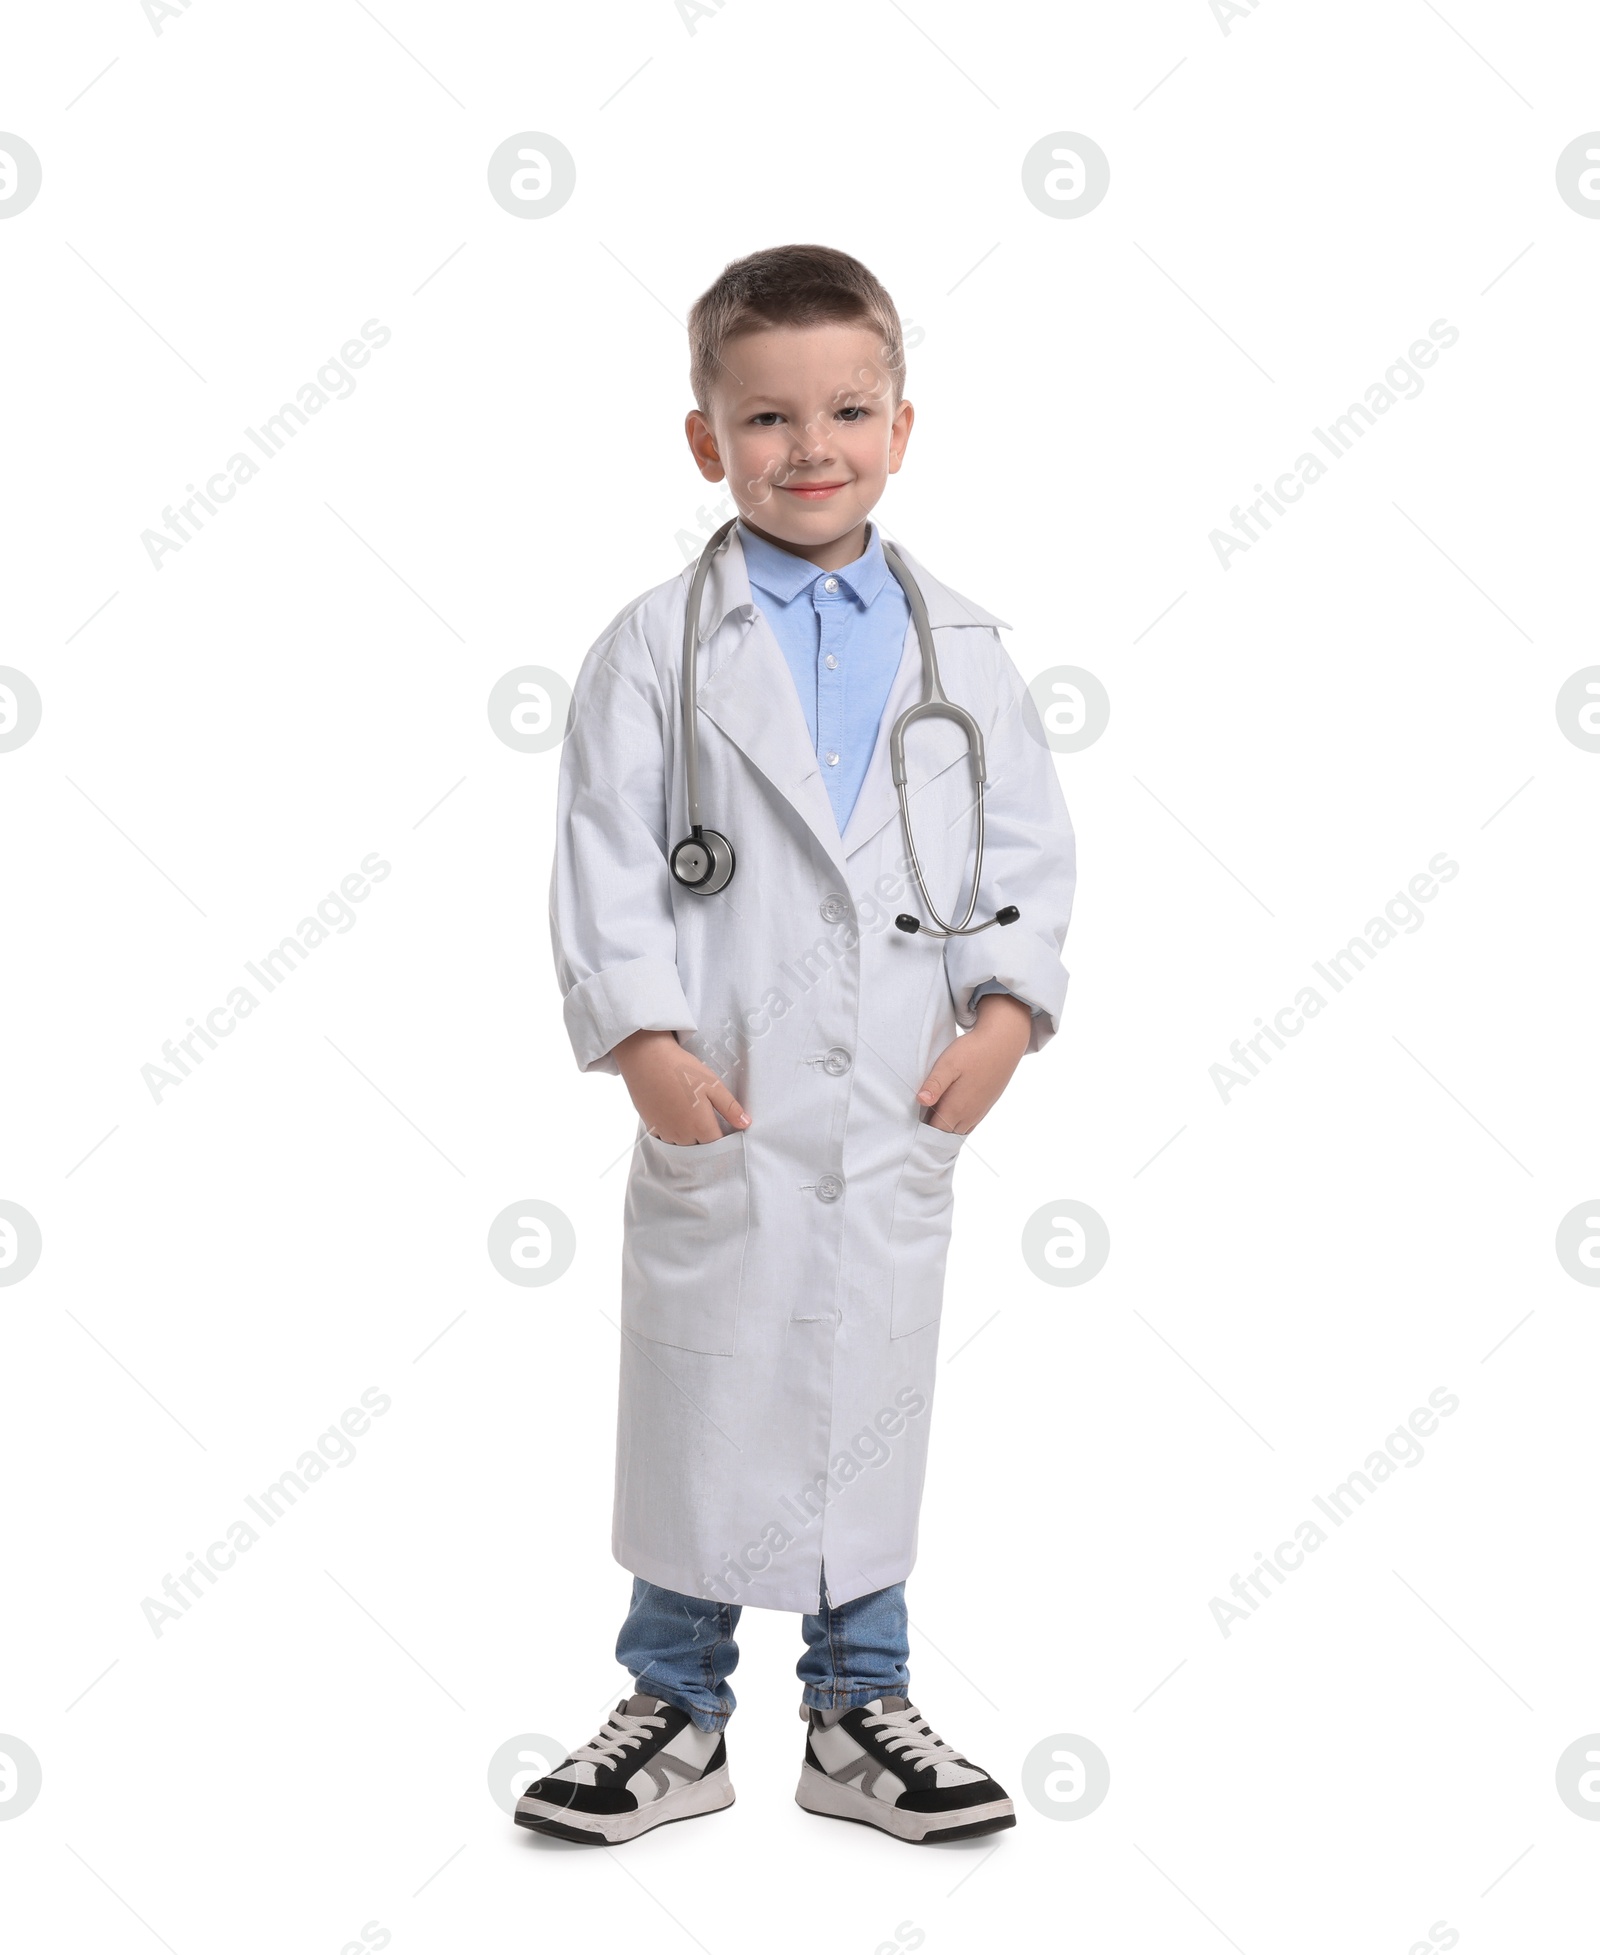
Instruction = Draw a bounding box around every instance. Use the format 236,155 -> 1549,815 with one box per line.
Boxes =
550,618 -> 696,1073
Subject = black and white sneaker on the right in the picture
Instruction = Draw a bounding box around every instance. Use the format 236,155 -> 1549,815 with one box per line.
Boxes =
794,1697 -> 1017,1842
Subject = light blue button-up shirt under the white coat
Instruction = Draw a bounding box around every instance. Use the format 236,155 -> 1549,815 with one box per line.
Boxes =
739,518 -> 1015,1003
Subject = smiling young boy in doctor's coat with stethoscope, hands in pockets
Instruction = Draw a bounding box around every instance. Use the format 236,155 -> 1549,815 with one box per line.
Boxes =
516,244 -> 1074,1844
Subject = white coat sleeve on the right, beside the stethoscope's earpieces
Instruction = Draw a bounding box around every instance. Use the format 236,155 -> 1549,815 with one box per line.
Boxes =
945,635 -> 1078,1052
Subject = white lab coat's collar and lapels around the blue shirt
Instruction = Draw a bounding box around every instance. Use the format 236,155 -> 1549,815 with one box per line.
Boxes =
683,526 -> 1009,890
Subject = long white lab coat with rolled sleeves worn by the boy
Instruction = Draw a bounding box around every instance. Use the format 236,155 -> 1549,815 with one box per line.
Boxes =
550,530 -> 1074,1611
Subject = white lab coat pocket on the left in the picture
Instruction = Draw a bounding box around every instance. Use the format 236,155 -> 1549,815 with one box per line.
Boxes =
622,1130 -> 749,1357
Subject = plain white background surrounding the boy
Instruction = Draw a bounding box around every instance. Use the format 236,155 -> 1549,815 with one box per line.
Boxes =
0,0 -> 1600,1955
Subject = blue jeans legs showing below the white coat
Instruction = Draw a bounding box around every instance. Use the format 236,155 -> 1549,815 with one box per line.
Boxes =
616,1576 -> 911,1730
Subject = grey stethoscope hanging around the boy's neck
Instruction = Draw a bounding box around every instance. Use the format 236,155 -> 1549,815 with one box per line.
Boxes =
669,516 -> 1021,936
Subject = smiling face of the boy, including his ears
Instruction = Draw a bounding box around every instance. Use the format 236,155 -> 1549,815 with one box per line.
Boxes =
685,325 -> 913,567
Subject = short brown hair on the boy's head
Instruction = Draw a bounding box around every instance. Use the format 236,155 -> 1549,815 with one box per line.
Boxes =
689,244 -> 906,414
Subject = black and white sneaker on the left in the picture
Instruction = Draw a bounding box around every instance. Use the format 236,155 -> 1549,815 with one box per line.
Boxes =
516,1693 -> 733,1846
